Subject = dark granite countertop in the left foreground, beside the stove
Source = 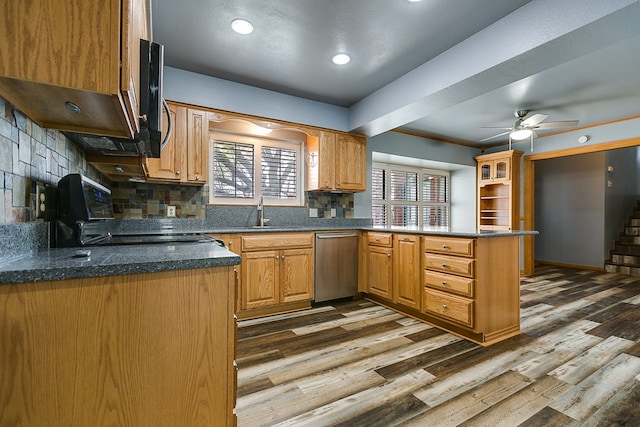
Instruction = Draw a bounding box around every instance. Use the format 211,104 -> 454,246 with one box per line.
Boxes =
0,242 -> 240,284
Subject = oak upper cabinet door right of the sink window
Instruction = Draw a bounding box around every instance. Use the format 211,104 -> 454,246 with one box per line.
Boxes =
336,134 -> 367,191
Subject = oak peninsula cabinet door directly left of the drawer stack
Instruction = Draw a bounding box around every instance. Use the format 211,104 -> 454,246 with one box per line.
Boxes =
393,234 -> 422,310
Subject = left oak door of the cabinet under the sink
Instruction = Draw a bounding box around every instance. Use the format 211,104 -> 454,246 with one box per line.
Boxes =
242,251 -> 280,310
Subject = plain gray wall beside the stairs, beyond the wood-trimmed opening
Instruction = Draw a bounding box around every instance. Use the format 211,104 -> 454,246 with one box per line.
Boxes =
535,147 -> 638,268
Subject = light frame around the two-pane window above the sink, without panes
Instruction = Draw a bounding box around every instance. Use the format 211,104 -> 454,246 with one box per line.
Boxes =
209,131 -> 305,206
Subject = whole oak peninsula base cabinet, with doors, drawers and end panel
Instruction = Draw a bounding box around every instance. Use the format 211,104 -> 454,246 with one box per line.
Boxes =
361,232 -> 520,345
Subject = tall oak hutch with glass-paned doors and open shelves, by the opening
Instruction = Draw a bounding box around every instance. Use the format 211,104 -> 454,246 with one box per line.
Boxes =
476,150 -> 522,230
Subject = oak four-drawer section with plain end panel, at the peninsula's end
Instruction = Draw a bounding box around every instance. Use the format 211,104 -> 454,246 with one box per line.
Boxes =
422,236 -> 520,345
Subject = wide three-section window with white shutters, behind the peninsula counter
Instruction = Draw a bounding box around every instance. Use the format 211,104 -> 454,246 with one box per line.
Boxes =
371,163 -> 449,228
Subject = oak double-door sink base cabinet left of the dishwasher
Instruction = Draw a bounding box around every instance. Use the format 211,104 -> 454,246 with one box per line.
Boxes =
239,233 -> 314,318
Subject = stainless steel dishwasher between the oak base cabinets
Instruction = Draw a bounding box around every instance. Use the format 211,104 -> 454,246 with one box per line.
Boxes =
314,231 -> 358,302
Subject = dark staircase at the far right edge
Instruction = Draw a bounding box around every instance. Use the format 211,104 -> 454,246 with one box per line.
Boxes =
604,200 -> 640,276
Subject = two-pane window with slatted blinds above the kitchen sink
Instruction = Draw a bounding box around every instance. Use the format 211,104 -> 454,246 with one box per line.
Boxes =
209,132 -> 303,205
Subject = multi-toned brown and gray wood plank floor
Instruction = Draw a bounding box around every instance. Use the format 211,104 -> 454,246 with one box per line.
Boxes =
237,266 -> 640,427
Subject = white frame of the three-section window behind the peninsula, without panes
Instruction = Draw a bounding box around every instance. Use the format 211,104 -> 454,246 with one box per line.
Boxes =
371,162 -> 451,230
